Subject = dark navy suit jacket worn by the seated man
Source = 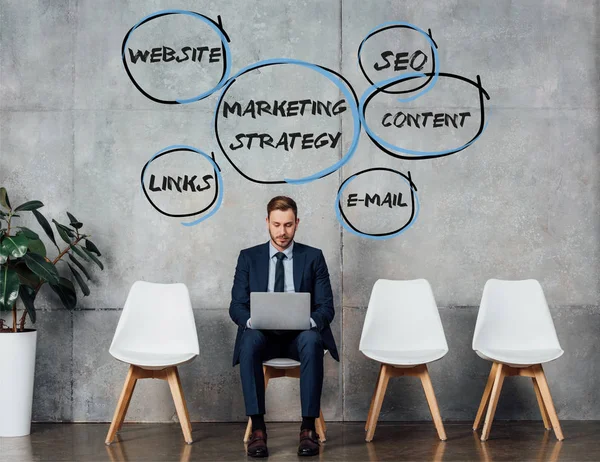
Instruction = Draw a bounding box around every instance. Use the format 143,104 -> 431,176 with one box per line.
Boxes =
229,242 -> 339,366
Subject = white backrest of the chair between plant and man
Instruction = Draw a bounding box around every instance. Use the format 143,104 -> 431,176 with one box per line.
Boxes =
110,281 -> 200,354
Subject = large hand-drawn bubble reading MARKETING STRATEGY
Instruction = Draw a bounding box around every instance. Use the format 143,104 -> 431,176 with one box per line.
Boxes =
214,59 -> 360,184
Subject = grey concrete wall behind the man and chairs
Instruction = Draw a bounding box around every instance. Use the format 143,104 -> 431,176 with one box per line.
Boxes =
0,0 -> 600,421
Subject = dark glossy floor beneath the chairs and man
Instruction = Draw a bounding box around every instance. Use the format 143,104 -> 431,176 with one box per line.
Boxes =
0,421 -> 600,462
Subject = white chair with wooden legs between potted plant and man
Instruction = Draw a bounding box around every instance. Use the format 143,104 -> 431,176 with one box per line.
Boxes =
105,281 -> 200,444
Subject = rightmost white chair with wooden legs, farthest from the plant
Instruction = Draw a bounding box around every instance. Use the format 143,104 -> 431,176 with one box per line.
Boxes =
473,279 -> 564,441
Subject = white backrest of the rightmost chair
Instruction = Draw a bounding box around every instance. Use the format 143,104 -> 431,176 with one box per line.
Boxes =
473,279 -> 560,350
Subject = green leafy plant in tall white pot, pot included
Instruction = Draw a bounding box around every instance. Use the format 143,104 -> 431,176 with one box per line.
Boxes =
0,188 -> 104,437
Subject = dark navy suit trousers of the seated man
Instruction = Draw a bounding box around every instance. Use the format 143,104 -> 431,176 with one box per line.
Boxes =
240,328 -> 324,417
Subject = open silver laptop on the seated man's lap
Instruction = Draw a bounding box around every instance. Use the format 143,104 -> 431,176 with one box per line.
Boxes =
250,292 -> 310,330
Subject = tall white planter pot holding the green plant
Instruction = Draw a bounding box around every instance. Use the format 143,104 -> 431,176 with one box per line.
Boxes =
0,330 -> 37,437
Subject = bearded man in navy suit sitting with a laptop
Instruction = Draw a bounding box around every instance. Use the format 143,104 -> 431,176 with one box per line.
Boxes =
229,196 -> 339,457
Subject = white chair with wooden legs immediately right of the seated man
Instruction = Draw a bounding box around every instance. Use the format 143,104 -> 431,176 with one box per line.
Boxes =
359,279 -> 448,442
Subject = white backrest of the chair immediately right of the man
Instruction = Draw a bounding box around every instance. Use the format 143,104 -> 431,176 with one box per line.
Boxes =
359,279 -> 448,351
